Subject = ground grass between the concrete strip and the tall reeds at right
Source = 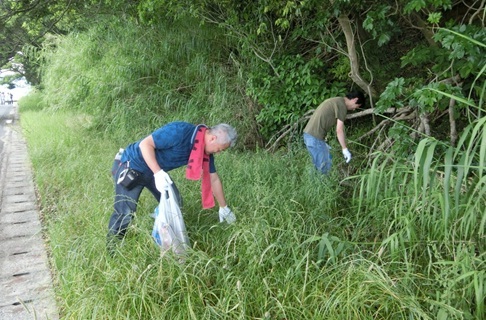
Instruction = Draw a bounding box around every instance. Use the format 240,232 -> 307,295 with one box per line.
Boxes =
21,111 -> 440,319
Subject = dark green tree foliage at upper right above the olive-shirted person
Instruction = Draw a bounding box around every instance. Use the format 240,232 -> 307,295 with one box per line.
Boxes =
134,0 -> 486,142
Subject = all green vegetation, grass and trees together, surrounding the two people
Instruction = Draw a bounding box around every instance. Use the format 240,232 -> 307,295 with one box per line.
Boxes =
4,0 -> 486,319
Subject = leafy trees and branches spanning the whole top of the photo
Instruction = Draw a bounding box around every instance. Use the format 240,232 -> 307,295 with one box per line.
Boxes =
0,0 -> 486,144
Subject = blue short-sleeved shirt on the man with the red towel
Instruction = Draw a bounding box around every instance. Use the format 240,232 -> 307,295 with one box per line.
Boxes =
121,122 -> 216,174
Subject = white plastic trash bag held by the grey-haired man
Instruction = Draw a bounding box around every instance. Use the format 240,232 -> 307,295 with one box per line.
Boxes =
152,186 -> 190,255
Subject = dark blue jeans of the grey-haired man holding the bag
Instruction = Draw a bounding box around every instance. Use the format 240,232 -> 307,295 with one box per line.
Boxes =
108,159 -> 182,238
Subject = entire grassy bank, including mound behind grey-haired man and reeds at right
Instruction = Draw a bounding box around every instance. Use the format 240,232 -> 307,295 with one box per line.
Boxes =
21,14 -> 486,319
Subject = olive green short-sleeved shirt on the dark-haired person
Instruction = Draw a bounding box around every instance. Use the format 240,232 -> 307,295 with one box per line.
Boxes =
304,97 -> 348,140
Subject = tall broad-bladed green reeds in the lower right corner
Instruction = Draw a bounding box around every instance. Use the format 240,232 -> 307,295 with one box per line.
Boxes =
354,118 -> 486,319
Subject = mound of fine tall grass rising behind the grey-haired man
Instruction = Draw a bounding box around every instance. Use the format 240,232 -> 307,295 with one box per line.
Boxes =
42,18 -> 257,148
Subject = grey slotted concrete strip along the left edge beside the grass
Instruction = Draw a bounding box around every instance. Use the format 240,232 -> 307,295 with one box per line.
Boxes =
0,104 -> 59,320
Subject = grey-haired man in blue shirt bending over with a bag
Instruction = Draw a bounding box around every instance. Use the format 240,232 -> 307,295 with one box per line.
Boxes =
108,122 -> 237,244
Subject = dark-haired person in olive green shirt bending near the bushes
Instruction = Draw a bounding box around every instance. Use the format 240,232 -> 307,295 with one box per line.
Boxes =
304,91 -> 365,174
